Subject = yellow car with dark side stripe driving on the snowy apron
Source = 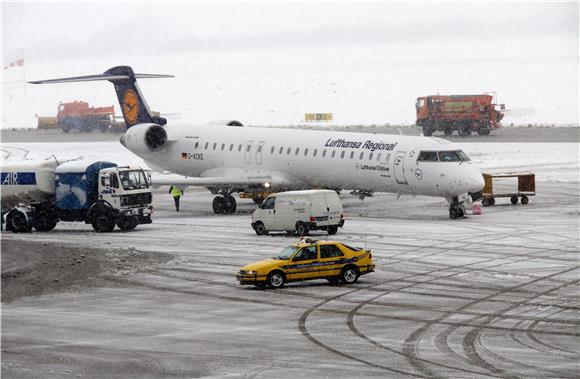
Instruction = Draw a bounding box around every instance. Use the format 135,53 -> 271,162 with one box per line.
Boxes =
236,239 -> 375,288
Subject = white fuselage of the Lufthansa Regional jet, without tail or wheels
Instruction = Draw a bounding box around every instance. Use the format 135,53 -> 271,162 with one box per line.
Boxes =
124,125 -> 483,198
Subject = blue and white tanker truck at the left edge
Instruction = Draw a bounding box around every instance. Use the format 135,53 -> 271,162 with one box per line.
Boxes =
0,159 -> 153,233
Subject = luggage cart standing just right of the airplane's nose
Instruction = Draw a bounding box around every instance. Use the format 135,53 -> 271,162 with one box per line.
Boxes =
481,172 -> 536,207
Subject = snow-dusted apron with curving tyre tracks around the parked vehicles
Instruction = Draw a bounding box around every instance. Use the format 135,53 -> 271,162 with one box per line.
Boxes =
2,142 -> 580,378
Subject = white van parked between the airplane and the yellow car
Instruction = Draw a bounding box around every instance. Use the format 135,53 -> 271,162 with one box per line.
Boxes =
252,190 -> 344,236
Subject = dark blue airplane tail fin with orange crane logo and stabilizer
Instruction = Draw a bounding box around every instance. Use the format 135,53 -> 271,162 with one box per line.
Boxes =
29,66 -> 174,129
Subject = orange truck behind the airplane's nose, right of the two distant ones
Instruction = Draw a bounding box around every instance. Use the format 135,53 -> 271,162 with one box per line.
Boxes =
415,94 -> 505,137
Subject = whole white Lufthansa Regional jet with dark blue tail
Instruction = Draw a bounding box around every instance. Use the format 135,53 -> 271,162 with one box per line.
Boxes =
29,66 -> 484,219
